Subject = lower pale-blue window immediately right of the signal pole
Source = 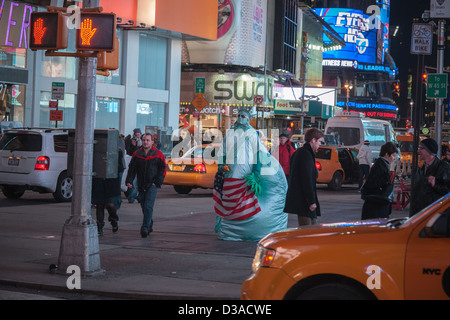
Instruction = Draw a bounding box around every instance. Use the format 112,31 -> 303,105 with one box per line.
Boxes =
95,97 -> 120,129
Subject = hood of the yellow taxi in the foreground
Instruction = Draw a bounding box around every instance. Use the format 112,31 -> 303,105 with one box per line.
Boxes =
260,217 -> 407,247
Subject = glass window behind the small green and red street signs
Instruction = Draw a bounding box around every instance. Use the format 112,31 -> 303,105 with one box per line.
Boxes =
39,91 -> 76,128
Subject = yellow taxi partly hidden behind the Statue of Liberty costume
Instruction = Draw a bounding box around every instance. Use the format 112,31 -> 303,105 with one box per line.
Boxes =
164,144 -> 220,194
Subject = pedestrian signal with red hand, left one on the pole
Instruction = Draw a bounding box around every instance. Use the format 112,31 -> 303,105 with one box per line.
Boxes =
29,12 -> 68,50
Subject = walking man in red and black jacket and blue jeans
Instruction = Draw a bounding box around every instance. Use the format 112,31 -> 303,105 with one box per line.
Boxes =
125,133 -> 166,238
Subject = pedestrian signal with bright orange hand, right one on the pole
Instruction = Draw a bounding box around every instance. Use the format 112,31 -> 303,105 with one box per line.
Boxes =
76,12 -> 116,51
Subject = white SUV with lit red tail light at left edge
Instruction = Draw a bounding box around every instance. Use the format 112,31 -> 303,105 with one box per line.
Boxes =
0,129 -> 73,201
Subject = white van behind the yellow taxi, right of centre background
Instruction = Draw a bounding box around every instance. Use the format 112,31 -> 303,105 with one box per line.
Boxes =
325,112 -> 397,159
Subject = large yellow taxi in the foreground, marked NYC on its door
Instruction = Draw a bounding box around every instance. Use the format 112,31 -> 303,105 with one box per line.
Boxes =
241,193 -> 450,300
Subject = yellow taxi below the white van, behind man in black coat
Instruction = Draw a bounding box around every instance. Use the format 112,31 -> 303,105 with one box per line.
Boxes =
316,146 -> 359,190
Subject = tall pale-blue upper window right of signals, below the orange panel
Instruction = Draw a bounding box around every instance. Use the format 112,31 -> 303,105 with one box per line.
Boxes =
138,33 -> 167,90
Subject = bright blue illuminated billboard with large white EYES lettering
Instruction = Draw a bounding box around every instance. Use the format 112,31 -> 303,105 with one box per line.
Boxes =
314,8 -> 380,63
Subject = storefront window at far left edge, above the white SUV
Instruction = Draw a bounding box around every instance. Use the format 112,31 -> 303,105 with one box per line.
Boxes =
0,83 -> 25,123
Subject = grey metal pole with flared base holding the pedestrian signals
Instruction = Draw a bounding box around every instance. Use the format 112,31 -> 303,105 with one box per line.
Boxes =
58,0 -> 102,274
